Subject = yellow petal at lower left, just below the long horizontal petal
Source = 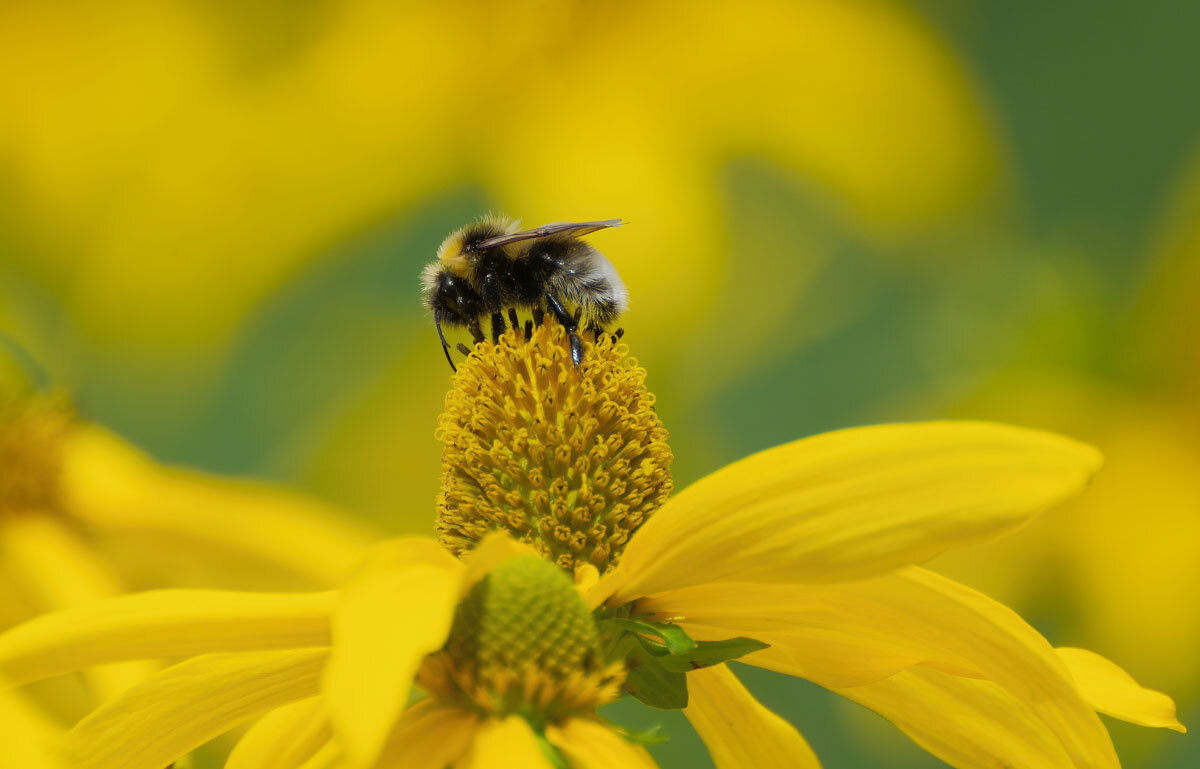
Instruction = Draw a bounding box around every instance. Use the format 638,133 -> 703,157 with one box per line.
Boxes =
66,649 -> 328,769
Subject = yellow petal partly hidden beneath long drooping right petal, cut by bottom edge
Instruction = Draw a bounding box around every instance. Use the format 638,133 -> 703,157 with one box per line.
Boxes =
834,667 -> 1080,769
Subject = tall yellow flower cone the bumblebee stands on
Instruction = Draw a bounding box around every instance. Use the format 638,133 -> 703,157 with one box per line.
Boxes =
437,322 -> 672,572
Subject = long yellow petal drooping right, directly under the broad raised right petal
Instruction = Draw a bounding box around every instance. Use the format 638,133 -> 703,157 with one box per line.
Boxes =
638,567 -> 1117,769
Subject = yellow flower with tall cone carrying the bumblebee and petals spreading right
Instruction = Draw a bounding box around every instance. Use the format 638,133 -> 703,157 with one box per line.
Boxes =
440,331 -> 1182,767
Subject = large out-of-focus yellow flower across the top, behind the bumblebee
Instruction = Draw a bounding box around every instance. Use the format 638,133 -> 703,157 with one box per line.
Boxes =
0,0 -> 997,354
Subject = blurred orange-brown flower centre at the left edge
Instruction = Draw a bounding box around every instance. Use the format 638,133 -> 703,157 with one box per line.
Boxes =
0,396 -> 74,515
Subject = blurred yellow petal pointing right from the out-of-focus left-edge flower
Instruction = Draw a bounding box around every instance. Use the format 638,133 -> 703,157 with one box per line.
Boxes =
62,426 -> 373,587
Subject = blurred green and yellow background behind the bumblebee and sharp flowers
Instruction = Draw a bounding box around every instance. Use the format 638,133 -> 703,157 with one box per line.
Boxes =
0,0 -> 1200,768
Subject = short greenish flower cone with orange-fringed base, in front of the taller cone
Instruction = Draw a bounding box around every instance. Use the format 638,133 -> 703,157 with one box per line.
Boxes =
419,555 -> 624,723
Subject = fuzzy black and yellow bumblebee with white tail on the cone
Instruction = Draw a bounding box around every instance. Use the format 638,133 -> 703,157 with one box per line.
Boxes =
421,216 -> 629,368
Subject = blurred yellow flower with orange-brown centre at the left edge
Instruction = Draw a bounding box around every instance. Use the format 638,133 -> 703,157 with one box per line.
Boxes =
0,396 -> 370,621
